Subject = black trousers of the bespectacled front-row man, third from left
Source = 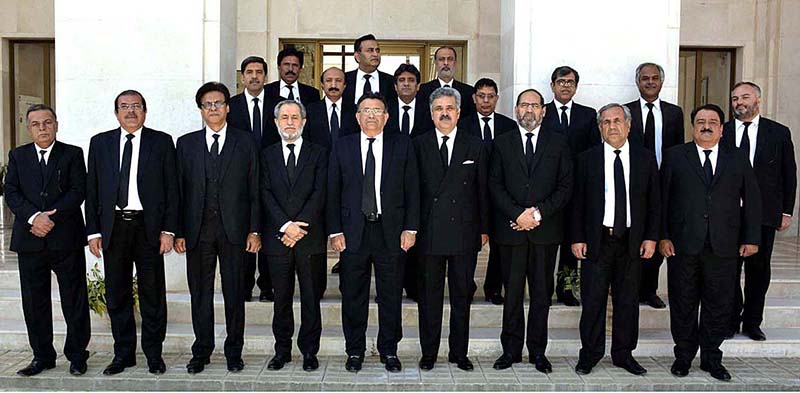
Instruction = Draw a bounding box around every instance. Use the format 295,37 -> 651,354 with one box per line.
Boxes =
186,212 -> 246,360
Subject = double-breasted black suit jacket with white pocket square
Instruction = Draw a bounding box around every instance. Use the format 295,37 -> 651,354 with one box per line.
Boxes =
413,130 -> 489,255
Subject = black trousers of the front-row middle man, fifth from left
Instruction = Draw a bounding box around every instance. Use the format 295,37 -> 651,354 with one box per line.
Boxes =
339,222 -> 404,356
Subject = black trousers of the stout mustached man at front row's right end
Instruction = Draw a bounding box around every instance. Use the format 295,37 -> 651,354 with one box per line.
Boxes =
667,244 -> 736,363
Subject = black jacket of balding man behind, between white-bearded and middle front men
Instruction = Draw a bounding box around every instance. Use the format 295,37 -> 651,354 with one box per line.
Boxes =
303,99 -> 360,151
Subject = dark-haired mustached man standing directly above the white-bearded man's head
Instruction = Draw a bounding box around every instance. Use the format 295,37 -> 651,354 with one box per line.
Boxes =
265,46 -> 319,106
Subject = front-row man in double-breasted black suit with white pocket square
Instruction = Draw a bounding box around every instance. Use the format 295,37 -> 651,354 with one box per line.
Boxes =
414,87 -> 489,371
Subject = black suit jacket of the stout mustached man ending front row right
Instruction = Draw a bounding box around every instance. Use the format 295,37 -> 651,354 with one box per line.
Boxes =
661,142 -> 761,258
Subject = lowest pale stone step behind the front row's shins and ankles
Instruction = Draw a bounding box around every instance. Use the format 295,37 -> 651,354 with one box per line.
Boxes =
0,320 -> 800,359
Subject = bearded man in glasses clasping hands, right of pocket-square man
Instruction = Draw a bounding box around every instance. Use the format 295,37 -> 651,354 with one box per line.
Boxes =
489,89 -> 573,373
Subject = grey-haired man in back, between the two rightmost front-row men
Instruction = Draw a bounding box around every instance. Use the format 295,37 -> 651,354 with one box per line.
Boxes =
625,63 -> 683,308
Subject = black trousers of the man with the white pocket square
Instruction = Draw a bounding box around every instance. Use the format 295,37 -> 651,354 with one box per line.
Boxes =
417,253 -> 478,358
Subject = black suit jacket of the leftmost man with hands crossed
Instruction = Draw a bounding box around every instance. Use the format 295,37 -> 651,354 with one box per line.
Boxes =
4,141 -> 86,252
